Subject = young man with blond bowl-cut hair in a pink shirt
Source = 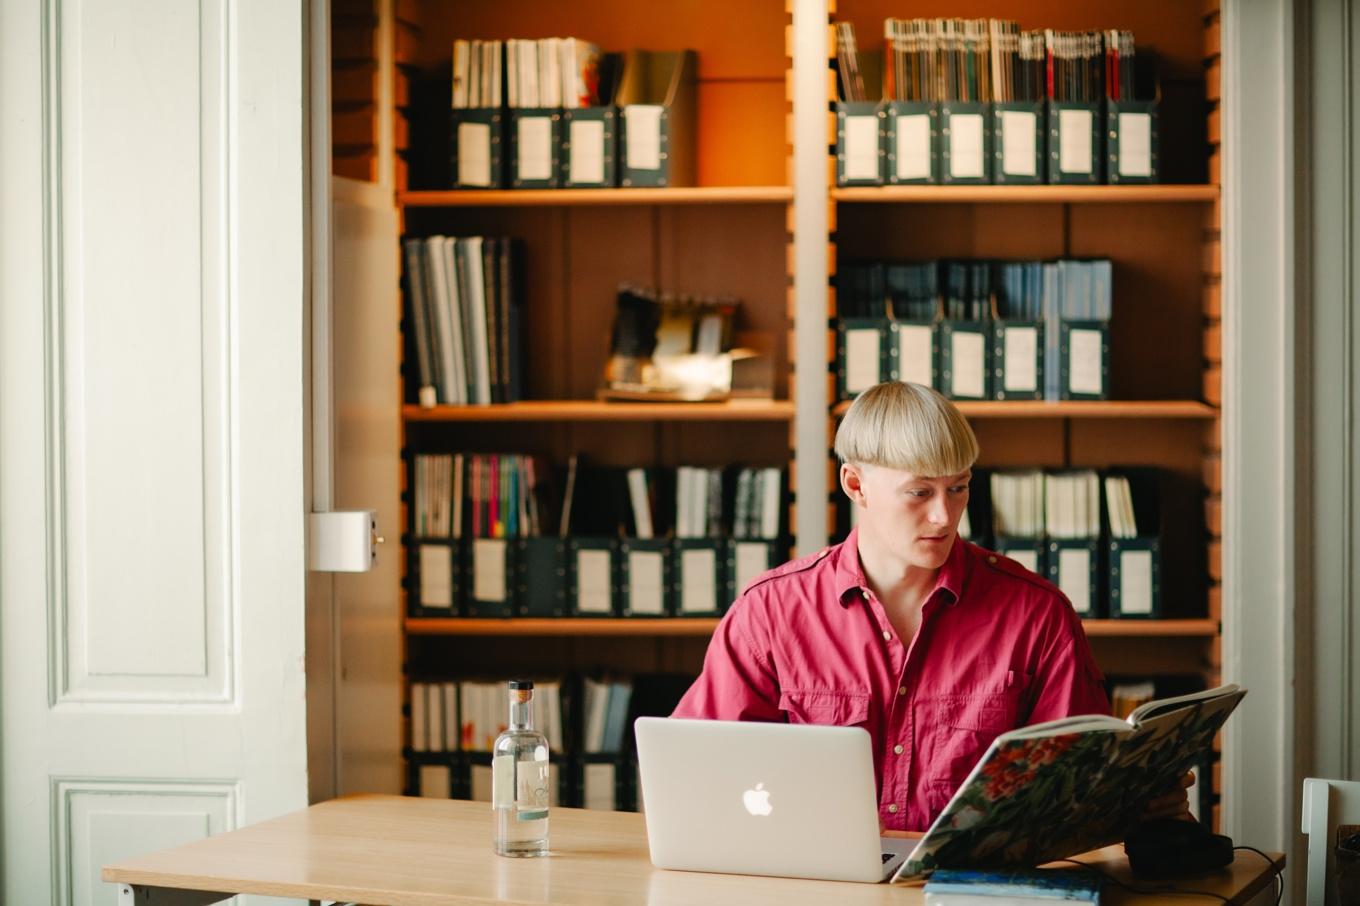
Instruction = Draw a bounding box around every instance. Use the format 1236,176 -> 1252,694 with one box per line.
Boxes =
673,382 -> 1186,831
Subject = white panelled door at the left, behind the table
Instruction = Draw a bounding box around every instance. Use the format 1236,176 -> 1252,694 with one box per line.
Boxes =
0,0 -> 307,905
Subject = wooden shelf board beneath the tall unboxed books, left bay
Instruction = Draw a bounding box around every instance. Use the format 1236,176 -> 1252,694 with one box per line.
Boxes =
401,400 -> 794,423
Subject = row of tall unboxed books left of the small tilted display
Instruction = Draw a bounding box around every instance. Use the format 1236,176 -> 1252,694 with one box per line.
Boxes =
403,235 -> 524,407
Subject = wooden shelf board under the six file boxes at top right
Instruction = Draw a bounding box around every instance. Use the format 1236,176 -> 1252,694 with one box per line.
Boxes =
831,185 -> 1219,204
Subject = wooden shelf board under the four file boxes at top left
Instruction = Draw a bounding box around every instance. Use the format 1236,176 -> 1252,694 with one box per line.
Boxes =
397,185 -> 793,208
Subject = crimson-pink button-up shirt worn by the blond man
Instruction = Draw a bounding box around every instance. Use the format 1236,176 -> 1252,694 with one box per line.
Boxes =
673,531 -> 1110,831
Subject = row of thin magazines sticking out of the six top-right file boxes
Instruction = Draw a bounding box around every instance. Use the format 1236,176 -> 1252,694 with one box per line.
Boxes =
835,18 -> 1146,102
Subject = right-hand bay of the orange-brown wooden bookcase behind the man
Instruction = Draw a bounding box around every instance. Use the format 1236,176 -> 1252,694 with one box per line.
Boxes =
827,0 -> 1221,824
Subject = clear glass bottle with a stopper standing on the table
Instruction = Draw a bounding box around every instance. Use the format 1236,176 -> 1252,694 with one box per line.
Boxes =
491,680 -> 548,857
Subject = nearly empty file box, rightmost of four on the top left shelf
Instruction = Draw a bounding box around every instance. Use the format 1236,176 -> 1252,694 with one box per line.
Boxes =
616,50 -> 699,186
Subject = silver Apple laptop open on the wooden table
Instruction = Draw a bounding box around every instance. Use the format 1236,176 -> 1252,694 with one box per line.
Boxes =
634,717 -> 915,882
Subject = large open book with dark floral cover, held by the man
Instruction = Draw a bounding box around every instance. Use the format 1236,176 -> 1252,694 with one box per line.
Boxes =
892,683 -> 1247,882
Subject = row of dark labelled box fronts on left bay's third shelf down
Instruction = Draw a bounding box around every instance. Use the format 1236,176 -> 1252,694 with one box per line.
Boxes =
405,536 -> 789,619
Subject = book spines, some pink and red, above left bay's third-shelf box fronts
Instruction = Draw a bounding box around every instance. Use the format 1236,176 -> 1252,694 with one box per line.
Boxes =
409,453 -> 787,540
